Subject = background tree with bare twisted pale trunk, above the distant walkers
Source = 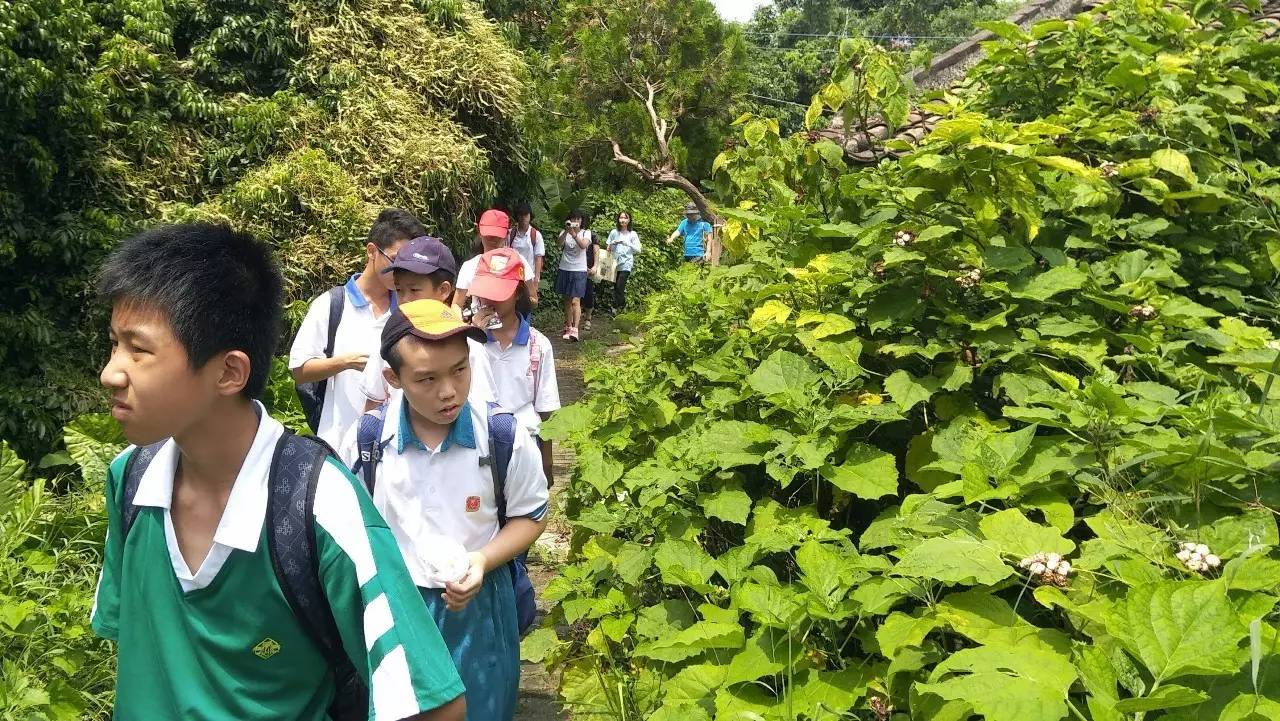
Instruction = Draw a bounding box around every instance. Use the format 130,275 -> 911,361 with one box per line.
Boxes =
547,0 -> 746,218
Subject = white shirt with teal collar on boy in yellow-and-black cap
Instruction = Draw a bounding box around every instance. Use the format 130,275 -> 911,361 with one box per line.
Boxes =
340,391 -> 549,588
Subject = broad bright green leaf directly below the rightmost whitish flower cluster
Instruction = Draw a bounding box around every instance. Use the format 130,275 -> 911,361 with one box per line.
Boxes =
1105,581 -> 1245,681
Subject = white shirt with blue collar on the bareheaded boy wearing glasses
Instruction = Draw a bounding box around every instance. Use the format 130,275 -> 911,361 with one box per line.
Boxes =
289,273 -> 396,446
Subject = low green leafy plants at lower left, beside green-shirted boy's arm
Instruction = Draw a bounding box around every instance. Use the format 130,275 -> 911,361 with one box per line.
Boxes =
0,425 -> 123,721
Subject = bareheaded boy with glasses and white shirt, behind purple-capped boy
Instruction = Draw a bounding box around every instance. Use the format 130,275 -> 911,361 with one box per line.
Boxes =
289,207 -> 426,447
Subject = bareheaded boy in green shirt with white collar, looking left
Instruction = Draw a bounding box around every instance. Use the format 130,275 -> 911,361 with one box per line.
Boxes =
92,224 -> 465,721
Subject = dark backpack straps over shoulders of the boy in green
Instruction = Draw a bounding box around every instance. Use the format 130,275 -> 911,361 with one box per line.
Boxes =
120,432 -> 369,721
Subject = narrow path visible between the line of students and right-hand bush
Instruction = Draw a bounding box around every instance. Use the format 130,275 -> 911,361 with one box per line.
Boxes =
516,309 -> 614,721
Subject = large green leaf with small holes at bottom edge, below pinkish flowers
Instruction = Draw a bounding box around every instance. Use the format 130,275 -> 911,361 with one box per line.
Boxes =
915,645 -> 1075,721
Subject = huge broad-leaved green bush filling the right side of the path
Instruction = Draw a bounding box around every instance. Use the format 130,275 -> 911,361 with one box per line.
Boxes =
525,0 -> 1280,721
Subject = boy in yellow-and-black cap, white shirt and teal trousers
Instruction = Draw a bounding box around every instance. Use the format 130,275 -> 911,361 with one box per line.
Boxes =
347,300 -> 548,721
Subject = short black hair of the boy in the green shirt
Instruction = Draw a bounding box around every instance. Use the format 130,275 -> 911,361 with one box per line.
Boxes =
97,223 -> 284,398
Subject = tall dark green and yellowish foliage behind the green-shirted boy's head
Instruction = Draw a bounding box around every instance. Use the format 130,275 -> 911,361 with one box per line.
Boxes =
0,0 -> 531,453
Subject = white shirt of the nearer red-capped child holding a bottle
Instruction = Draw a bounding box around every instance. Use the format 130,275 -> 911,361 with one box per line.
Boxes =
484,318 -> 561,437
